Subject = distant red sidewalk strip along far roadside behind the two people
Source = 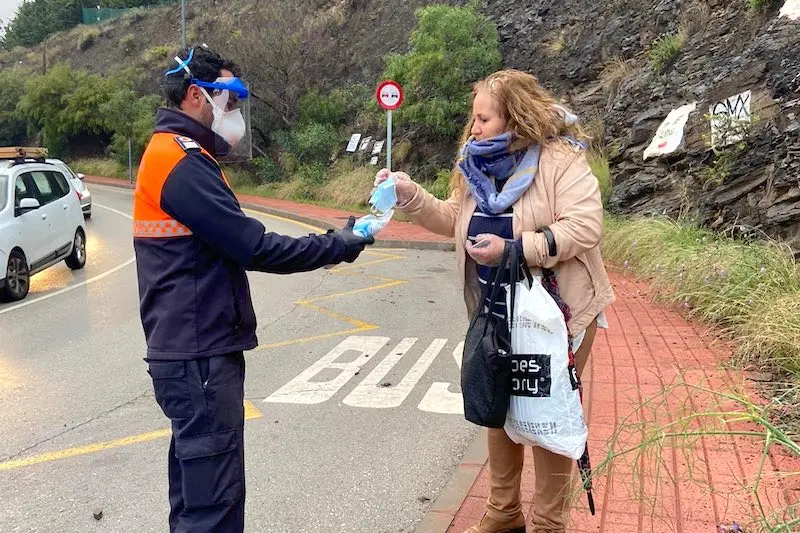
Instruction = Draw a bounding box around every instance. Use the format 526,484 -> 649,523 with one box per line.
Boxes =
84,176 -> 453,250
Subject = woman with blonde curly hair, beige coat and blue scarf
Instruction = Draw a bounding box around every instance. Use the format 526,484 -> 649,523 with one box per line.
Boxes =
376,70 -> 614,533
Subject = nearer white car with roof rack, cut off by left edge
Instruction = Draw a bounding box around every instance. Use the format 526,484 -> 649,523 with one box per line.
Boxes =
0,152 -> 86,301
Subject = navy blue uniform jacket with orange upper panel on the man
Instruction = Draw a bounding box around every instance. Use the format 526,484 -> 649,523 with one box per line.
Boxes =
133,109 -> 345,360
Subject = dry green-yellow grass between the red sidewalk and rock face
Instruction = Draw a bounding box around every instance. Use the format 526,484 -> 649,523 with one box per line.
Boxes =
603,217 -> 800,376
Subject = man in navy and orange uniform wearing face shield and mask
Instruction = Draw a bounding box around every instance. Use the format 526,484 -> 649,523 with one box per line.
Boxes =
134,47 -> 374,533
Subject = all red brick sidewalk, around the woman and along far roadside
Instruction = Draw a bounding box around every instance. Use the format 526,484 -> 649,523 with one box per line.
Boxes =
87,177 -> 800,533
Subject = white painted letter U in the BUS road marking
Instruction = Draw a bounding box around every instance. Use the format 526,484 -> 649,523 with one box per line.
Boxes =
344,339 -> 447,409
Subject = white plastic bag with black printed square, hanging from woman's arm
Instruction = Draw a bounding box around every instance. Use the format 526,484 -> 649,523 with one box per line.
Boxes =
505,276 -> 589,460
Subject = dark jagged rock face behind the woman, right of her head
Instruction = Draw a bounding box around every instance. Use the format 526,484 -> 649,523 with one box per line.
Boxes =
486,0 -> 800,250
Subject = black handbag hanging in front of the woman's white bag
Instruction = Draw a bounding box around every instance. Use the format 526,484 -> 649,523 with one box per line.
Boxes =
461,243 -> 527,428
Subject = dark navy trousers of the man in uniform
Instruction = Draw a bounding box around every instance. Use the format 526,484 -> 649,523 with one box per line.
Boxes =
147,352 -> 245,533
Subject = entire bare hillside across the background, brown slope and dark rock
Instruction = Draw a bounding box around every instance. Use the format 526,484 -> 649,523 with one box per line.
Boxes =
0,0 -> 800,250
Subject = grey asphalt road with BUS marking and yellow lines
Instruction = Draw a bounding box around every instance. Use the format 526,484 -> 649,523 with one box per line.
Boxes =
0,186 -> 476,533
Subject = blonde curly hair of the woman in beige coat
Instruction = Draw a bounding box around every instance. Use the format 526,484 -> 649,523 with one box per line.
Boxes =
450,69 -> 589,195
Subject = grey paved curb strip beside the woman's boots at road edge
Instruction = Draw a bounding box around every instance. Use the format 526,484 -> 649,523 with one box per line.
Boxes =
414,429 -> 489,533
